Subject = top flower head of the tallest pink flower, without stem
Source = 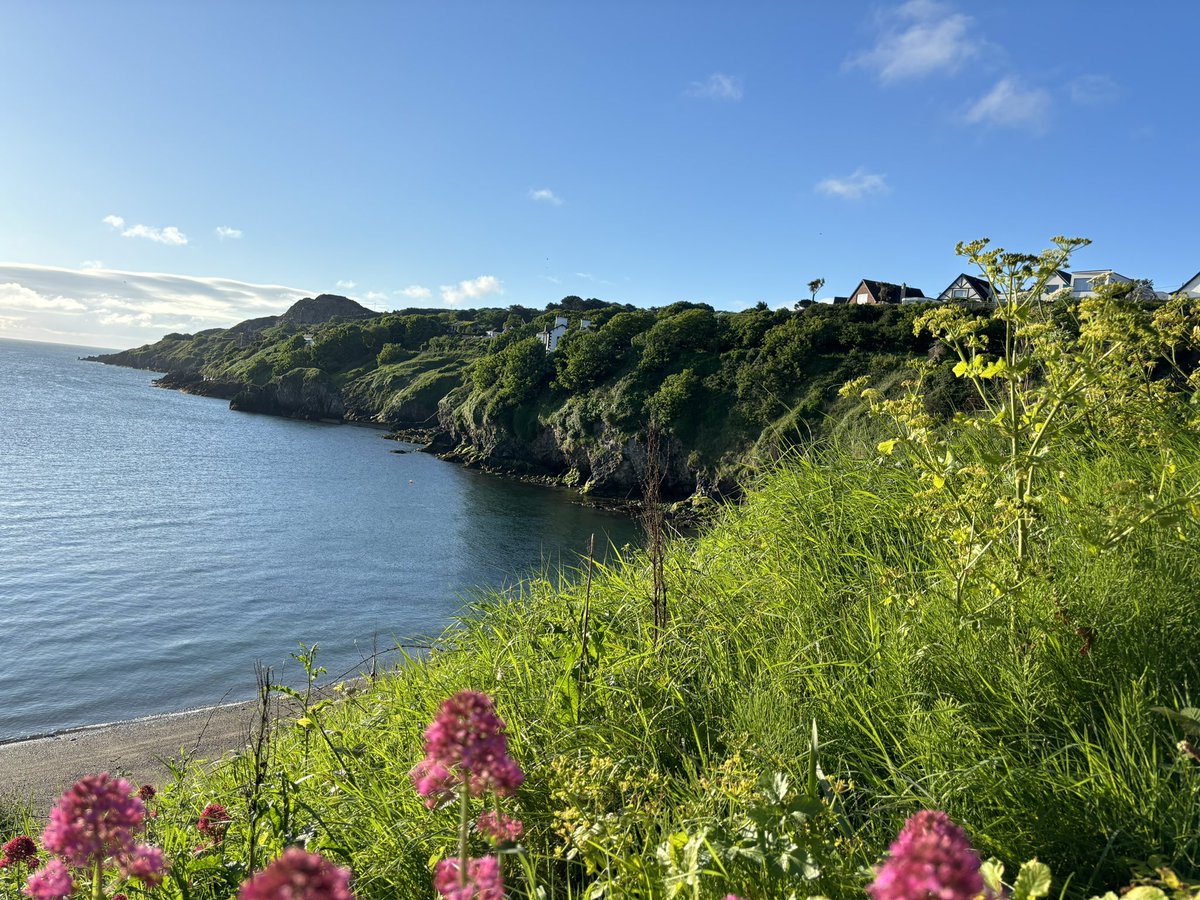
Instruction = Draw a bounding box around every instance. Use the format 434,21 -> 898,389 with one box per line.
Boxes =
409,691 -> 524,809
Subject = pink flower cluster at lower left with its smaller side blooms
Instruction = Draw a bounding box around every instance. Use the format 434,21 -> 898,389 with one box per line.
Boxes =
25,772 -> 166,900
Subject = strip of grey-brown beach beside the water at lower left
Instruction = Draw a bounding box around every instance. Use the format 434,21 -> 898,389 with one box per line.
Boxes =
0,701 -> 264,818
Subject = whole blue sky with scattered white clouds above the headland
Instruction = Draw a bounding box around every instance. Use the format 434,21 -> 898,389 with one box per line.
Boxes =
0,0 -> 1200,347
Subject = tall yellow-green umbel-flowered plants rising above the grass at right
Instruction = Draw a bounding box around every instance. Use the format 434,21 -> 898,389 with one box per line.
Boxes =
844,236 -> 1200,604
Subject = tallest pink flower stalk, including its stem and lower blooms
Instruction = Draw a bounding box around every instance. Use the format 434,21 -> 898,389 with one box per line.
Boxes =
409,690 -> 524,900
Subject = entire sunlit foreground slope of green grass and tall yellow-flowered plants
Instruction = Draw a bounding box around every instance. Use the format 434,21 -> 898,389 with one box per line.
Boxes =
25,241 -> 1200,900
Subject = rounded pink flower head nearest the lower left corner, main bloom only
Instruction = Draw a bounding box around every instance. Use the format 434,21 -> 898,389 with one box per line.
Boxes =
42,772 -> 145,869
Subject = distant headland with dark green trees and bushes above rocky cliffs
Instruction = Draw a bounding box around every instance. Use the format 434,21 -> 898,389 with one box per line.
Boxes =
91,290 -> 953,496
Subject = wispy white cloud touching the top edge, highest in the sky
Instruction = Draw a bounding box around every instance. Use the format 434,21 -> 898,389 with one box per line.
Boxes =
846,0 -> 985,84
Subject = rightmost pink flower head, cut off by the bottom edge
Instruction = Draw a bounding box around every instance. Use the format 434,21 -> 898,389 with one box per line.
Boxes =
866,810 -> 984,900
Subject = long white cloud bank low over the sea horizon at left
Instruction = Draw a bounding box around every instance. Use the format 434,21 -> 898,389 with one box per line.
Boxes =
0,263 -> 314,347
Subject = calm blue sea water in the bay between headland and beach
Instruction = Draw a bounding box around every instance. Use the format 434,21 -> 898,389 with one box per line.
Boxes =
0,341 -> 636,740
